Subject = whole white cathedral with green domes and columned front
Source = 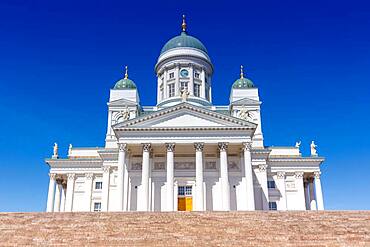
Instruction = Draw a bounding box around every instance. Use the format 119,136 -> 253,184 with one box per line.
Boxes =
46,16 -> 324,212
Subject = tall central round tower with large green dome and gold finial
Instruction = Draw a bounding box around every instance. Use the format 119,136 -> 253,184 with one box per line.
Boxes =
155,16 -> 213,108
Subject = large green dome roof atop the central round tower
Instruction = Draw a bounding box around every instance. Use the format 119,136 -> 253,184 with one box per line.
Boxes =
161,31 -> 208,54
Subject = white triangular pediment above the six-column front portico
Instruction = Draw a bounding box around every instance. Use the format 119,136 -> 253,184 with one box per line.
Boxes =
113,103 -> 256,129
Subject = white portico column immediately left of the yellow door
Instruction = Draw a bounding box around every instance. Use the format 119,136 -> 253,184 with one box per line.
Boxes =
166,143 -> 175,211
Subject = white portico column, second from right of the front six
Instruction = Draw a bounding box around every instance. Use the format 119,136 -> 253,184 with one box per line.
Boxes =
218,142 -> 230,211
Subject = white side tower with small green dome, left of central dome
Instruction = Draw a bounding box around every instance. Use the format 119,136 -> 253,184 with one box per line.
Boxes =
105,66 -> 140,148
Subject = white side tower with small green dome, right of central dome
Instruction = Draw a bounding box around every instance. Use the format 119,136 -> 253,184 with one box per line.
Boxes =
230,65 -> 264,148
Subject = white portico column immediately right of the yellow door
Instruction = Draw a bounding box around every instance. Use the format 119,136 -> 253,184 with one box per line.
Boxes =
194,143 -> 204,211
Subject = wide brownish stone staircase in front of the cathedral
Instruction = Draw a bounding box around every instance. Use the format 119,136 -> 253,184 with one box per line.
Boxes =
0,211 -> 370,246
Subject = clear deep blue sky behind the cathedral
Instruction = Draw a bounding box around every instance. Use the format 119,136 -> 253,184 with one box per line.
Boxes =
0,0 -> 370,211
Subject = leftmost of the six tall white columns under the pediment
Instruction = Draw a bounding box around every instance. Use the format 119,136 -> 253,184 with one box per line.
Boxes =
117,143 -> 127,211
